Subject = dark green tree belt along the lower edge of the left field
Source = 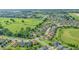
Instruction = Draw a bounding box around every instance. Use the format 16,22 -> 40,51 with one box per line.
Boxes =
0,24 -> 32,38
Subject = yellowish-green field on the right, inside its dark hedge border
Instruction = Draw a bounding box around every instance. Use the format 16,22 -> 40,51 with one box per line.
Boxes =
59,28 -> 79,48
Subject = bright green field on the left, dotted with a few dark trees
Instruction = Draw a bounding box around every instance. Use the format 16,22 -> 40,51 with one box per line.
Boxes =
0,18 -> 43,33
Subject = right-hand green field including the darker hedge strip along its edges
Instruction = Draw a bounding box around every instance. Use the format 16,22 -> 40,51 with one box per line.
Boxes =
55,28 -> 79,49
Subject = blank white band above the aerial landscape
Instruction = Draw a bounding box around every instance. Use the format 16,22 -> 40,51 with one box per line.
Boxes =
0,0 -> 79,9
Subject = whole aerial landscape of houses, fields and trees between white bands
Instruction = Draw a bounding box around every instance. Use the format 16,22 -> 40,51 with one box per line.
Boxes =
0,9 -> 79,50
